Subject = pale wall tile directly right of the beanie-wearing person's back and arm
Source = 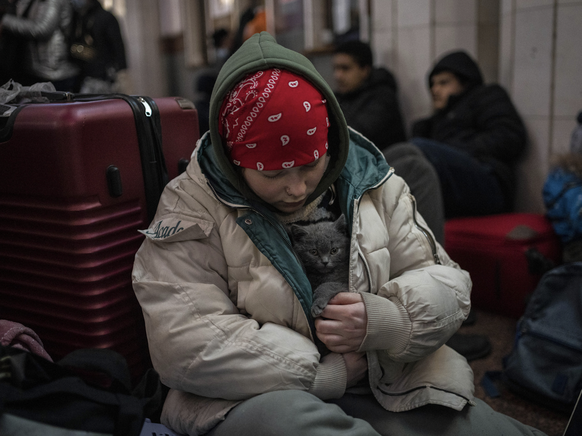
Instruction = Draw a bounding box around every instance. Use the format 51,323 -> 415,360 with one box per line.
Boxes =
515,117 -> 549,213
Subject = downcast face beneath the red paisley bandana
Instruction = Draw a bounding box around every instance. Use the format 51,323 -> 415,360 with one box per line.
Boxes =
242,153 -> 329,213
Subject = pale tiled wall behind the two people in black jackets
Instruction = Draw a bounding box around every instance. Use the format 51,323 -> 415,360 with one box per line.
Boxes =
372,0 -> 582,212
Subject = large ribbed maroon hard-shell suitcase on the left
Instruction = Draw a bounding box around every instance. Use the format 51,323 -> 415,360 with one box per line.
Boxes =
0,96 -> 199,378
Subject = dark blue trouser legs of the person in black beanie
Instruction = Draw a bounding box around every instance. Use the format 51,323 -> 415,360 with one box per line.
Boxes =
411,138 -> 506,219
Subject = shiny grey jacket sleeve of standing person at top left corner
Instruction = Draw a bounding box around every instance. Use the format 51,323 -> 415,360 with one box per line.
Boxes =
2,0 -> 64,40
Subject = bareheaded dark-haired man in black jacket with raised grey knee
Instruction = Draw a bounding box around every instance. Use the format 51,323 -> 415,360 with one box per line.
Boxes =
333,41 -> 444,244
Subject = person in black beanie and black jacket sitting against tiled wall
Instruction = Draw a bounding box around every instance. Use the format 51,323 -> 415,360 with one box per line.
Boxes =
411,51 -> 527,218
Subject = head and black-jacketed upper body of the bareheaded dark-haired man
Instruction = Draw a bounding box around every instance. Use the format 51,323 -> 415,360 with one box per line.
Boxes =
333,41 -> 406,150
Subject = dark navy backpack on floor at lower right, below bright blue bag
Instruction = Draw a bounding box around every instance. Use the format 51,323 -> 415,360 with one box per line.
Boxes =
483,262 -> 582,413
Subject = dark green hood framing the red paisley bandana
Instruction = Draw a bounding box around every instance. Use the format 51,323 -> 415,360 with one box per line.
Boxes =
209,32 -> 349,206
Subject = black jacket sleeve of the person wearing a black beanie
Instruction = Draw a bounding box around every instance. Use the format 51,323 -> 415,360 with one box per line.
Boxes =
445,85 -> 527,162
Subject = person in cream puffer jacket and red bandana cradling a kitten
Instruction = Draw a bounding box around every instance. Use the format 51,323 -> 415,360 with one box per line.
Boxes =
133,32 -> 542,436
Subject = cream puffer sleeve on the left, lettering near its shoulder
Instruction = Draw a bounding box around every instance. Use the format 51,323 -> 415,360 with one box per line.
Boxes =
133,192 -> 347,400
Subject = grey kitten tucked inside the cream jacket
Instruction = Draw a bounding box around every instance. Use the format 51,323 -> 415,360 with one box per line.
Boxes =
289,215 -> 350,317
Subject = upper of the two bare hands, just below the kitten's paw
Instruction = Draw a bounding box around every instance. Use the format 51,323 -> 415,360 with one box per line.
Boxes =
315,292 -> 368,354
